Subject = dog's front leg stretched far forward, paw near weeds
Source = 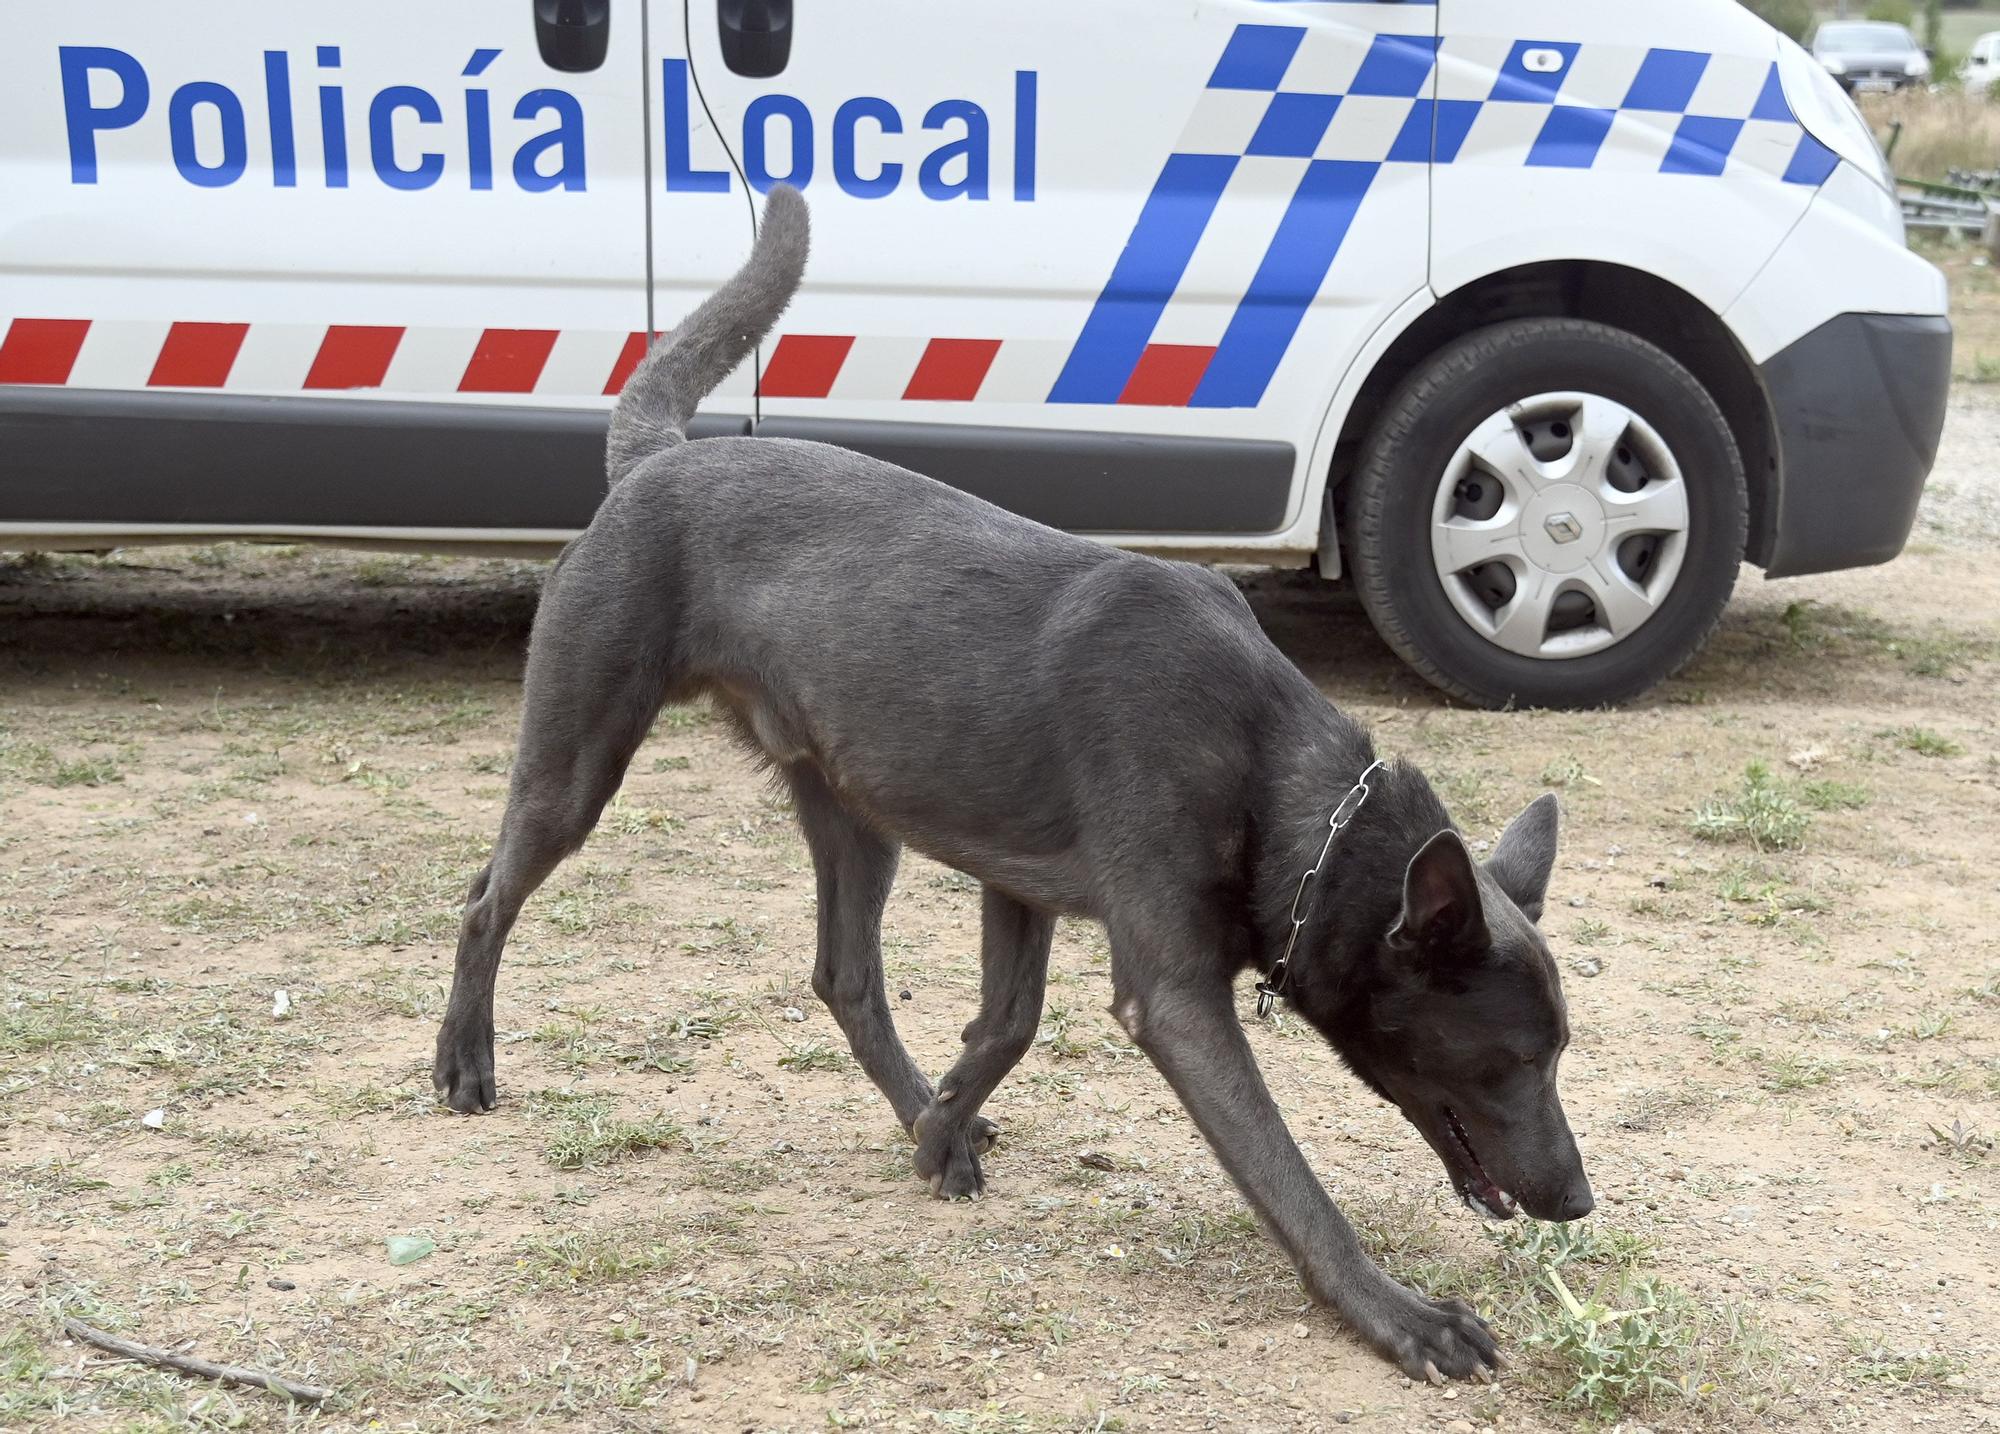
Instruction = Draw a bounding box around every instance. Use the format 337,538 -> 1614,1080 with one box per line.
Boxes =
1112,944 -> 1500,1382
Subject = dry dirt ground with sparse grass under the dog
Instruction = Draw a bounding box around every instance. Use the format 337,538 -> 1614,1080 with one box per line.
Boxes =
0,398 -> 2000,1434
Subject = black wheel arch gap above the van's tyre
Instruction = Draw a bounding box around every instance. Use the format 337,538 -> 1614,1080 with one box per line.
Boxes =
1328,260 -> 1782,564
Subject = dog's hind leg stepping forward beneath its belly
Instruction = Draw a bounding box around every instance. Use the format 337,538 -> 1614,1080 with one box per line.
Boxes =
786,762 -> 930,1130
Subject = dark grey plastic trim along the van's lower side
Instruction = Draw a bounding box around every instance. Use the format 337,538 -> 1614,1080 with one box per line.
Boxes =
0,386 -> 1296,536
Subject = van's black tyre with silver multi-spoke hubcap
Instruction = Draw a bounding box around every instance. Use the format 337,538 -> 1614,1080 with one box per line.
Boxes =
1346,318 -> 1748,708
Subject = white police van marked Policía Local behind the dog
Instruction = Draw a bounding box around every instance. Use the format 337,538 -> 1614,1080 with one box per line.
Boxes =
0,0 -> 1950,706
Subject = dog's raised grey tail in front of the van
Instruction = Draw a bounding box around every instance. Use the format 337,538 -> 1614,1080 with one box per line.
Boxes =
604,184 -> 812,482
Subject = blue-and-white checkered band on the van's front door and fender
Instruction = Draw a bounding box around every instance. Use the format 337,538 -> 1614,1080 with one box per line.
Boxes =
1048,26 -> 1838,408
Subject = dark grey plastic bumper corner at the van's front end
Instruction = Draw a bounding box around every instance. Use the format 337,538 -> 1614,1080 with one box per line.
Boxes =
1750,314 -> 1952,578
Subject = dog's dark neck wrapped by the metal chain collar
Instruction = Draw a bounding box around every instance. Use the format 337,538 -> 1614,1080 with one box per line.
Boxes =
1256,706 -> 1452,980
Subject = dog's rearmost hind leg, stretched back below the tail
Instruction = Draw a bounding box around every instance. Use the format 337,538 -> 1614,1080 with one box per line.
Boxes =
432,554 -> 670,1114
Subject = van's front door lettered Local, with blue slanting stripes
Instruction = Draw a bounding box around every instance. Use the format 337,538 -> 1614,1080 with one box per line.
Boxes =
668,0 -> 1436,548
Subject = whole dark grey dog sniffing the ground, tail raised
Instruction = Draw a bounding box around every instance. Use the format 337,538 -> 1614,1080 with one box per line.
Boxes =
436,188 -> 1592,1380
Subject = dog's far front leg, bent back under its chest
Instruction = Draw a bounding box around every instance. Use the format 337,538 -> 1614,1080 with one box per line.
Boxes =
914,886 -> 1056,1200
